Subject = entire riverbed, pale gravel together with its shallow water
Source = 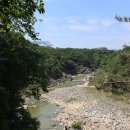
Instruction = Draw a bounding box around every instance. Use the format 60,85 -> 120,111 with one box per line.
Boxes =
30,73 -> 130,130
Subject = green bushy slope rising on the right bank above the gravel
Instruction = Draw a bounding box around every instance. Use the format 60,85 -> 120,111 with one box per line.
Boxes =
91,46 -> 130,95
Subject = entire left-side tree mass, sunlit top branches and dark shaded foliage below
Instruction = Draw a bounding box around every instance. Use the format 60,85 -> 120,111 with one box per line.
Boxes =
0,0 -> 46,130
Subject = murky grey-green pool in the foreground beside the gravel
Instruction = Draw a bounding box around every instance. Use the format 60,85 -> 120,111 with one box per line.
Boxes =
29,102 -> 64,130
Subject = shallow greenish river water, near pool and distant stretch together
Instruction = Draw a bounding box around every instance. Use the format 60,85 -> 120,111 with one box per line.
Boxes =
28,74 -> 85,130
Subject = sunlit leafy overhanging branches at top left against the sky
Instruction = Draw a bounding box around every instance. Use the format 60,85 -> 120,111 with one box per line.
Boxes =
0,0 -> 45,39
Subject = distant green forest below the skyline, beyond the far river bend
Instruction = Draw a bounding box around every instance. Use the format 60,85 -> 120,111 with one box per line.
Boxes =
36,45 -> 112,80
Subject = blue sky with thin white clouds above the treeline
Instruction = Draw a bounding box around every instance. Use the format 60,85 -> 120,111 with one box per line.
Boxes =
35,0 -> 130,49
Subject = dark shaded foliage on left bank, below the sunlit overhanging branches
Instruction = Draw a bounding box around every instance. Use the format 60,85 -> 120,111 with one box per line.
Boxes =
0,33 -> 48,130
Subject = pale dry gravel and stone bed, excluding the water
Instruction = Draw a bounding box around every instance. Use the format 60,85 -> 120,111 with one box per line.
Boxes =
41,74 -> 130,130
